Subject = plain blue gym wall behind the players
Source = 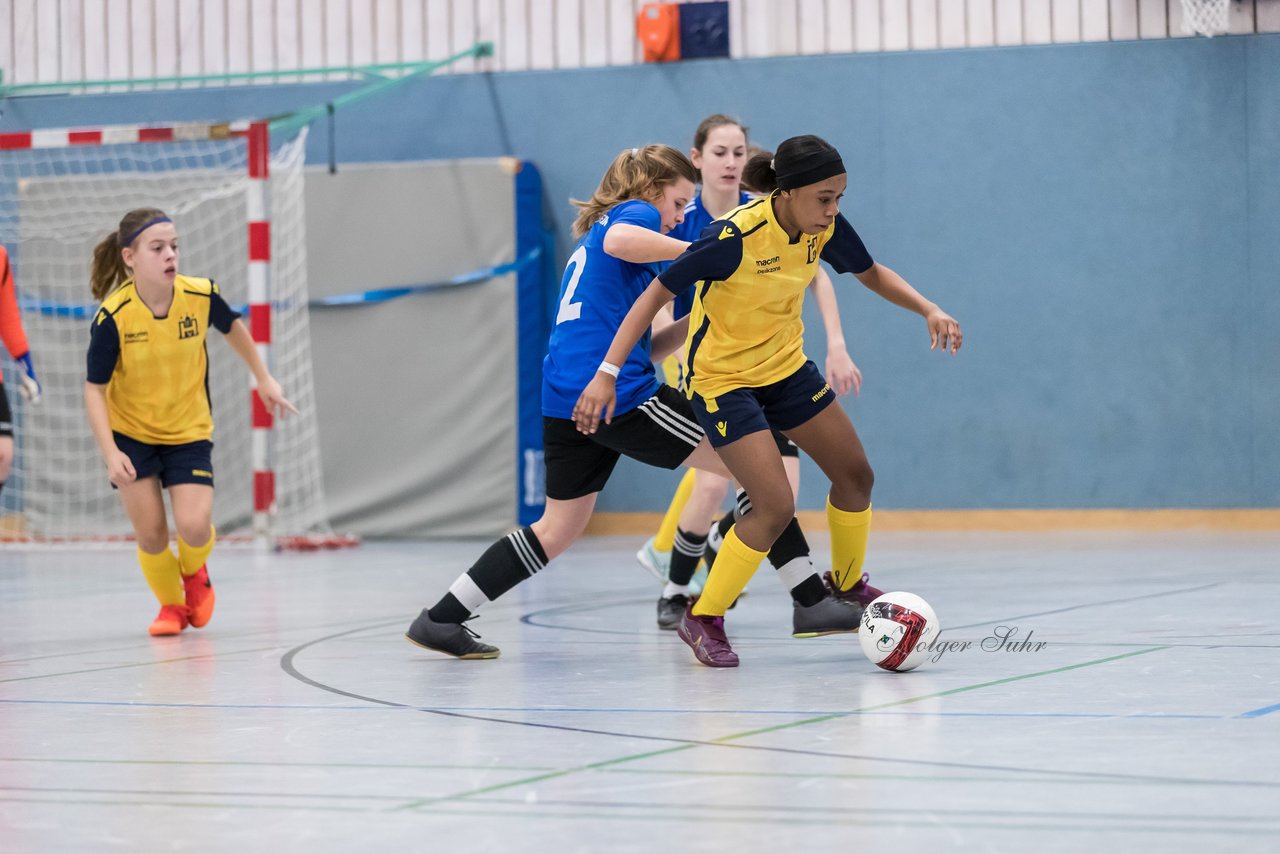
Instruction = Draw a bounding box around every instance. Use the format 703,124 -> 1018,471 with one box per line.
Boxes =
0,36 -> 1280,511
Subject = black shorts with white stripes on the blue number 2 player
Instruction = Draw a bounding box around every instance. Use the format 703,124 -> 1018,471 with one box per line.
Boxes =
543,385 -> 703,501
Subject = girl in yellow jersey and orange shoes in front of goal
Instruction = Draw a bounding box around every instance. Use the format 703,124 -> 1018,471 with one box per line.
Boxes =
84,207 -> 297,635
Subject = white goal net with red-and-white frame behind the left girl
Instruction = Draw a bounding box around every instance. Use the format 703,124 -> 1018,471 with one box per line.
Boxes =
0,125 -> 330,542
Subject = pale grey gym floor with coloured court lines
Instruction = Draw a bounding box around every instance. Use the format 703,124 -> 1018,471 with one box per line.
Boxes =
0,530 -> 1280,854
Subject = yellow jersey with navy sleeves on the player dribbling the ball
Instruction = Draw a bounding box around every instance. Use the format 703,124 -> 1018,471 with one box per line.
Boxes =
658,196 -> 873,399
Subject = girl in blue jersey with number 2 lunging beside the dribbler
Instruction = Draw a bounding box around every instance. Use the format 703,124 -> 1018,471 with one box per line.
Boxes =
406,145 -> 742,658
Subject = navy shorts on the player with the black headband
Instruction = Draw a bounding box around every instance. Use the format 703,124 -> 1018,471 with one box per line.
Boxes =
692,361 -> 836,448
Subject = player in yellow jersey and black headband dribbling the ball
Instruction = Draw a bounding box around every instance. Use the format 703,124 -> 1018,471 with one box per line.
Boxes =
573,136 -> 961,667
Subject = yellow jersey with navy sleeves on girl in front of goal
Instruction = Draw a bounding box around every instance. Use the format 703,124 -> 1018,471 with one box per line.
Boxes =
88,275 -> 239,444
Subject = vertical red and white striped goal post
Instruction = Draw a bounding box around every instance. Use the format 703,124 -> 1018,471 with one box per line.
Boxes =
247,122 -> 275,545
